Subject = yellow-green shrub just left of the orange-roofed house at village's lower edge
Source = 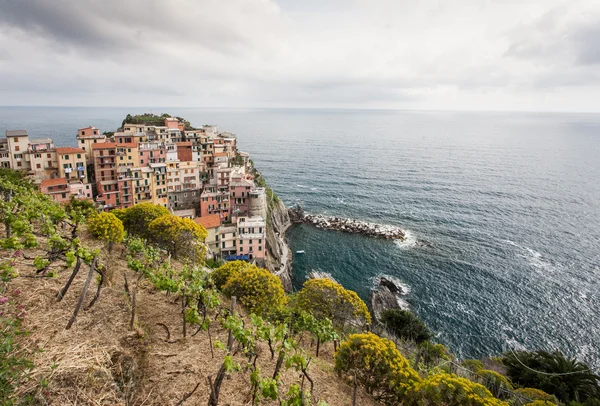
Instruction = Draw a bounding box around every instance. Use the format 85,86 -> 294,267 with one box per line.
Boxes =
147,214 -> 207,263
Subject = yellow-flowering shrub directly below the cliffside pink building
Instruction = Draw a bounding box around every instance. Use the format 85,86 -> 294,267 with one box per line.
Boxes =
223,267 -> 287,315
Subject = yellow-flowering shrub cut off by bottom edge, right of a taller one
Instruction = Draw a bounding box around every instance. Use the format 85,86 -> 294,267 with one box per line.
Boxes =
403,373 -> 508,406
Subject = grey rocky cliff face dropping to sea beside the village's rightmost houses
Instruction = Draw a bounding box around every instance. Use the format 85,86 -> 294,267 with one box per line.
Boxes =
266,199 -> 292,292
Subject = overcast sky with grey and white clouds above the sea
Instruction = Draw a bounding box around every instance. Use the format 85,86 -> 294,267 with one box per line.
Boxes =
0,0 -> 600,112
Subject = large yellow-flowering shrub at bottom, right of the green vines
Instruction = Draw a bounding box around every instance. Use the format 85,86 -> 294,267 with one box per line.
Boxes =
335,333 -> 420,404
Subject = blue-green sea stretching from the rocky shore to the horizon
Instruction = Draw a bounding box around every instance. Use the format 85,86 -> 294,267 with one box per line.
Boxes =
0,108 -> 600,367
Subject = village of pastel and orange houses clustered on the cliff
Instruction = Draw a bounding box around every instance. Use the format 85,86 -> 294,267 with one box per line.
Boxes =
0,115 -> 267,265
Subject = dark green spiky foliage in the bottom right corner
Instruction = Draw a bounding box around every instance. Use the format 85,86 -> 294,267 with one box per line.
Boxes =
502,350 -> 600,403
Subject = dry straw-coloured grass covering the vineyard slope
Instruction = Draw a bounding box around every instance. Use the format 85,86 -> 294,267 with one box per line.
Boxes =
11,235 -> 376,406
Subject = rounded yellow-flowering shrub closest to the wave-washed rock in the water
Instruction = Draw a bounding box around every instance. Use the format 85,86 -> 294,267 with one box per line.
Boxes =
296,278 -> 371,328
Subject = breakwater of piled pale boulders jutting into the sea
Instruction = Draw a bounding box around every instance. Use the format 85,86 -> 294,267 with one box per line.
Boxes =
289,204 -> 406,240
